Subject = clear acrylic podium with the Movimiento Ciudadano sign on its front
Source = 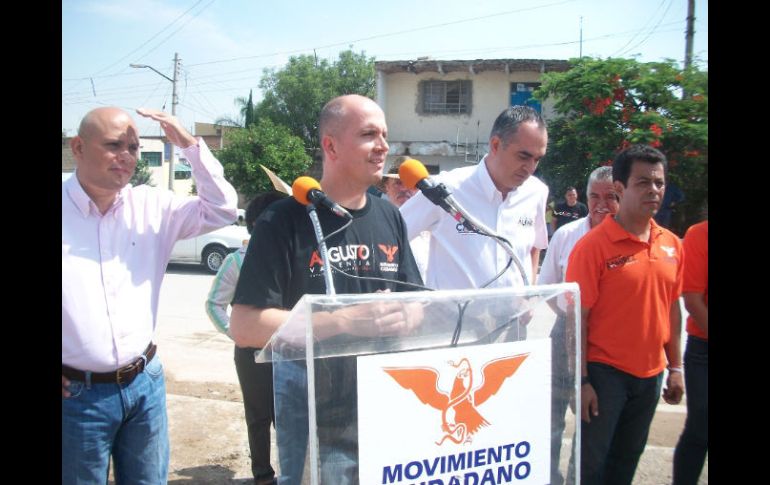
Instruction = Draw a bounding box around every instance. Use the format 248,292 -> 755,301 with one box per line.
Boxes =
256,283 -> 580,485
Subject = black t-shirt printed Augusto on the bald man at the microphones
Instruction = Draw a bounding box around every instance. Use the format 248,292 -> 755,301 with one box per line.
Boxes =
233,191 -> 422,309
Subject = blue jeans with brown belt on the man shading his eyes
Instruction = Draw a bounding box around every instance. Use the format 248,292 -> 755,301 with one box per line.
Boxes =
61,355 -> 169,485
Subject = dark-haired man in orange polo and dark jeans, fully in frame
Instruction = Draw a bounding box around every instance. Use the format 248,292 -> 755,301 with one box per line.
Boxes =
566,145 -> 684,485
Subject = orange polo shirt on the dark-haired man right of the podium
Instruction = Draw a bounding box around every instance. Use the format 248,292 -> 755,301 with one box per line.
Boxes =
566,217 -> 683,378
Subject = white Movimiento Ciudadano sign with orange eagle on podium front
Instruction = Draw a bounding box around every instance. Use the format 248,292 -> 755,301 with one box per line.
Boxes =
358,339 -> 551,484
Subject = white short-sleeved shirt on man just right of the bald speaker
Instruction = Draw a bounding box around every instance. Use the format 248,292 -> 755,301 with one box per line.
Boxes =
401,156 -> 548,289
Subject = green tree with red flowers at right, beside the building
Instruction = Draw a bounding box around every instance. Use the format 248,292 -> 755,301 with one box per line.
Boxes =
534,58 -> 708,234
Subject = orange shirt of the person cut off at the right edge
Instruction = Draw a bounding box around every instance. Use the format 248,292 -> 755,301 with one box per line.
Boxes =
682,221 -> 709,340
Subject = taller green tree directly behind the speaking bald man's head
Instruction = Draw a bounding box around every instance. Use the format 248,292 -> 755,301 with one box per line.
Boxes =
255,50 -> 375,155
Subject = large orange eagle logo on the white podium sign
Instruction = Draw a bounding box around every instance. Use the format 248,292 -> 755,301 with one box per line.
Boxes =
383,353 -> 529,445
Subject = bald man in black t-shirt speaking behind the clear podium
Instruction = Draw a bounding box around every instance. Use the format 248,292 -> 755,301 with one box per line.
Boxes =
231,95 -> 422,484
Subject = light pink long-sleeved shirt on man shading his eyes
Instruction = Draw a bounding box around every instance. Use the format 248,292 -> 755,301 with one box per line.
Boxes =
62,139 -> 238,372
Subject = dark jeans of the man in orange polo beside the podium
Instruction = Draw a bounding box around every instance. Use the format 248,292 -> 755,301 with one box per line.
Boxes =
580,362 -> 663,485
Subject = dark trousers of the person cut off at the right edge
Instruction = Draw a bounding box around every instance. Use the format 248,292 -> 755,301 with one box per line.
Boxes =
674,335 -> 709,485
